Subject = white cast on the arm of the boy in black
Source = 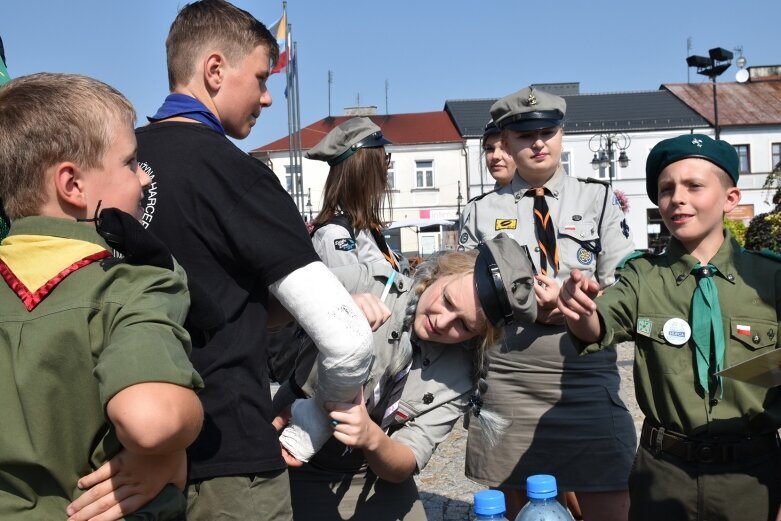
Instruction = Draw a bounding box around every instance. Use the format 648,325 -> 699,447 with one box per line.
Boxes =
269,262 -> 372,461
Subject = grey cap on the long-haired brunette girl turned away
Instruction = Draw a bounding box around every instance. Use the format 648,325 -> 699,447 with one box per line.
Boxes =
306,118 -> 390,166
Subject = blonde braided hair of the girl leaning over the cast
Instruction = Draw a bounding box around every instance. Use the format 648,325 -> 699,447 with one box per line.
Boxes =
389,250 -> 512,446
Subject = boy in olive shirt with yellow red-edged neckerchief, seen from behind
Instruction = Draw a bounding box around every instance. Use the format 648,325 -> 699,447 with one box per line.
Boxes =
0,74 -> 203,521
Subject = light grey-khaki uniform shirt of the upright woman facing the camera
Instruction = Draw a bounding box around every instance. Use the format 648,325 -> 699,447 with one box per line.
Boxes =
459,167 -> 634,287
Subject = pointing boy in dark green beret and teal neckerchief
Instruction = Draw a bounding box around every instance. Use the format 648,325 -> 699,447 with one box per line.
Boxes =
559,134 -> 781,520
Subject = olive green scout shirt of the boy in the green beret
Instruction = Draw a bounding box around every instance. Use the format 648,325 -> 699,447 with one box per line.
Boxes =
584,232 -> 781,439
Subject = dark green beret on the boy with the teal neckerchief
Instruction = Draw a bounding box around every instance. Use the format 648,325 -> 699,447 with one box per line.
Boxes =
645,134 -> 740,205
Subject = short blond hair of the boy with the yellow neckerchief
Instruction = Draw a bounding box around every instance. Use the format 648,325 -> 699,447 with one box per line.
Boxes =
0,73 -> 136,219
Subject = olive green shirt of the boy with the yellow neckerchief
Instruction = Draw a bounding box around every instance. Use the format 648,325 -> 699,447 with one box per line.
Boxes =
0,217 -> 202,521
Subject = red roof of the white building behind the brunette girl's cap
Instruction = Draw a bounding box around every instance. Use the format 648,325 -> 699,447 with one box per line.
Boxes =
250,110 -> 463,154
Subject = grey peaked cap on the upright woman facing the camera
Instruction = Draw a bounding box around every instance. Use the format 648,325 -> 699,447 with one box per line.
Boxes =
491,87 -> 567,132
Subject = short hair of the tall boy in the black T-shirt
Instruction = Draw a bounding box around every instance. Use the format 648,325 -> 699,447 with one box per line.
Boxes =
165,0 -> 279,90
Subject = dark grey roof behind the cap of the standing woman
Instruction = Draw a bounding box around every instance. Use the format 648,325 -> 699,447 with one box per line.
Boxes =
445,90 -> 708,138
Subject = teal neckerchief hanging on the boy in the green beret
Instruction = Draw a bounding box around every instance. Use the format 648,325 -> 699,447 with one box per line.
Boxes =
691,262 -> 724,396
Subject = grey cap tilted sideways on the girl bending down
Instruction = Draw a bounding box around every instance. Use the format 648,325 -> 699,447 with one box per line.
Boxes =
475,233 -> 537,327
